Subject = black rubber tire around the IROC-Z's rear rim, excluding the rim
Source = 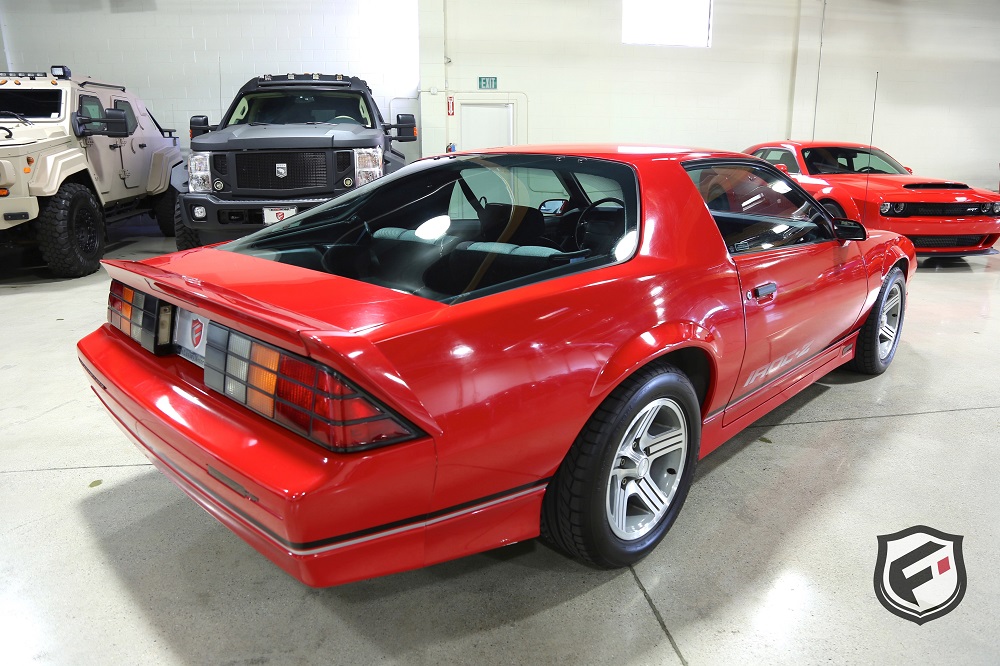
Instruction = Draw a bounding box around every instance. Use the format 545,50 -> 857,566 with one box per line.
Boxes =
541,365 -> 701,568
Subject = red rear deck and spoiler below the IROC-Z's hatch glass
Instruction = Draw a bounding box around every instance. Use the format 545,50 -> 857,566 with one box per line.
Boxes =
104,247 -> 447,335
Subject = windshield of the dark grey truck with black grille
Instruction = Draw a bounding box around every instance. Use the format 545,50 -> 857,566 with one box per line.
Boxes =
222,89 -> 374,128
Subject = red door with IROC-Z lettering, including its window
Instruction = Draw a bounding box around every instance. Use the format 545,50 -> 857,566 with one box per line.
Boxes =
688,162 -> 867,424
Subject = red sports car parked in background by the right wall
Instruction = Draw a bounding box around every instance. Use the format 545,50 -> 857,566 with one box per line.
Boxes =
743,141 -> 1000,256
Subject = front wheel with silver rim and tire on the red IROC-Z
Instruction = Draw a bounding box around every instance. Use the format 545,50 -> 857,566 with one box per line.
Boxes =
848,267 -> 906,375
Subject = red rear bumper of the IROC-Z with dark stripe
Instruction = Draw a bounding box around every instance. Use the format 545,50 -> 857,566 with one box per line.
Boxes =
78,326 -> 434,587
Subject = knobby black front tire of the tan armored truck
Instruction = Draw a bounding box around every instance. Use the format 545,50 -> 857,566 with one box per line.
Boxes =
35,183 -> 104,277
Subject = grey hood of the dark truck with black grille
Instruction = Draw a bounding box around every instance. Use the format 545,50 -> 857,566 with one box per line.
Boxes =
191,123 -> 385,151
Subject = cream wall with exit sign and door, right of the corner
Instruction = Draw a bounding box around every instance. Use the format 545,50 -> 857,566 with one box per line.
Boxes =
420,0 -> 1000,188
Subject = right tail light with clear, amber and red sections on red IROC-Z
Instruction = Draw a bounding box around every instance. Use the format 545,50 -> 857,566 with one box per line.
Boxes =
205,323 -> 423,451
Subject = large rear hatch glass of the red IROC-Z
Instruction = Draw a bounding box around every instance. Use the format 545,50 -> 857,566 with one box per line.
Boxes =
221,155 -> 638,303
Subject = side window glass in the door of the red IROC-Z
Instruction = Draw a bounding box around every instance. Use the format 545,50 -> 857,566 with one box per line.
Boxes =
687,163 -> 833,254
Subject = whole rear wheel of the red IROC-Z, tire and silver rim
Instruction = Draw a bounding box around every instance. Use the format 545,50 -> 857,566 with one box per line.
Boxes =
541,366 -> 701,568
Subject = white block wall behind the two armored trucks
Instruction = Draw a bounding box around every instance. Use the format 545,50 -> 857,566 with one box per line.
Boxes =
0,0 -> 419,157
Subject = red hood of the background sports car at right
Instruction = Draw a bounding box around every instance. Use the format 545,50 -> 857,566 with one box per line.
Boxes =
809,173 -> 997,203
